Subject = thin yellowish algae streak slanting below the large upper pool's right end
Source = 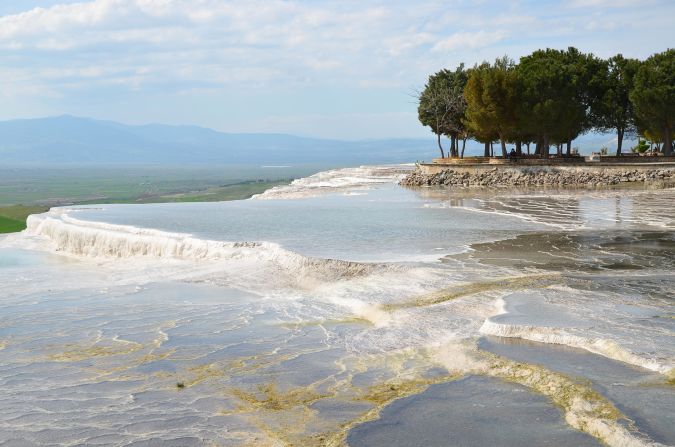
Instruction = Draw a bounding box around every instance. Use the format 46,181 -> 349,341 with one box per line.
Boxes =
381,274 -> 561,312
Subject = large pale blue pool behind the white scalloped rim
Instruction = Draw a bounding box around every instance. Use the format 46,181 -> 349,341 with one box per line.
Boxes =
73,184 -> 536,261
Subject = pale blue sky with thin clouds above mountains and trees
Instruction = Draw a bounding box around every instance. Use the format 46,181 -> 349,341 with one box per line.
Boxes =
0,0 -> 675,139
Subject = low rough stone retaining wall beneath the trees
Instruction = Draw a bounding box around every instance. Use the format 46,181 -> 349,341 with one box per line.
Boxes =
400,167 -> 675,187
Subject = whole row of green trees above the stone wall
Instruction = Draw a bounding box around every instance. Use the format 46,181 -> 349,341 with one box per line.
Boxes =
417,47 -> 675,157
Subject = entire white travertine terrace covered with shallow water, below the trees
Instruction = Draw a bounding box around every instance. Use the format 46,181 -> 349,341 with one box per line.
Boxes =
0,166 -> 675,446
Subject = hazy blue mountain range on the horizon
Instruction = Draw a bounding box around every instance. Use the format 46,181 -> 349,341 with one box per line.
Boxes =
0,115 -> 444,165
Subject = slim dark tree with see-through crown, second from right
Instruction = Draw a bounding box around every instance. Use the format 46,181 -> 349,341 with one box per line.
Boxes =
591,54 -> 640,156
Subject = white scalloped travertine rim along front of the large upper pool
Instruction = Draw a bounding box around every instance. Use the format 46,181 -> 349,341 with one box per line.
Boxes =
25,209 -> 396,285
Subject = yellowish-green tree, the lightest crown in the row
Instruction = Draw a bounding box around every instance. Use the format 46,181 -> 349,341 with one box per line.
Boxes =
464,56 -> 517,158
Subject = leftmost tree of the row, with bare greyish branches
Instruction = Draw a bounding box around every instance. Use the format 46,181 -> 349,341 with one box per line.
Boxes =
417,64 -> 467,157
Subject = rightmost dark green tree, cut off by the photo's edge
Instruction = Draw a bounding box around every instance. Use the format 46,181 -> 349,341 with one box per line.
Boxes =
629,49 -> 675,155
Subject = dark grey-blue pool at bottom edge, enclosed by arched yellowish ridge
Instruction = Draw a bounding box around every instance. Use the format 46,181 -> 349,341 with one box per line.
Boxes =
347,376 -> 601,447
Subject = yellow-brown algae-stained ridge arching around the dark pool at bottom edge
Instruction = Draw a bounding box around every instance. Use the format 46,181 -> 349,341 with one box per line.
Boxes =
218,341 -> 648,447
